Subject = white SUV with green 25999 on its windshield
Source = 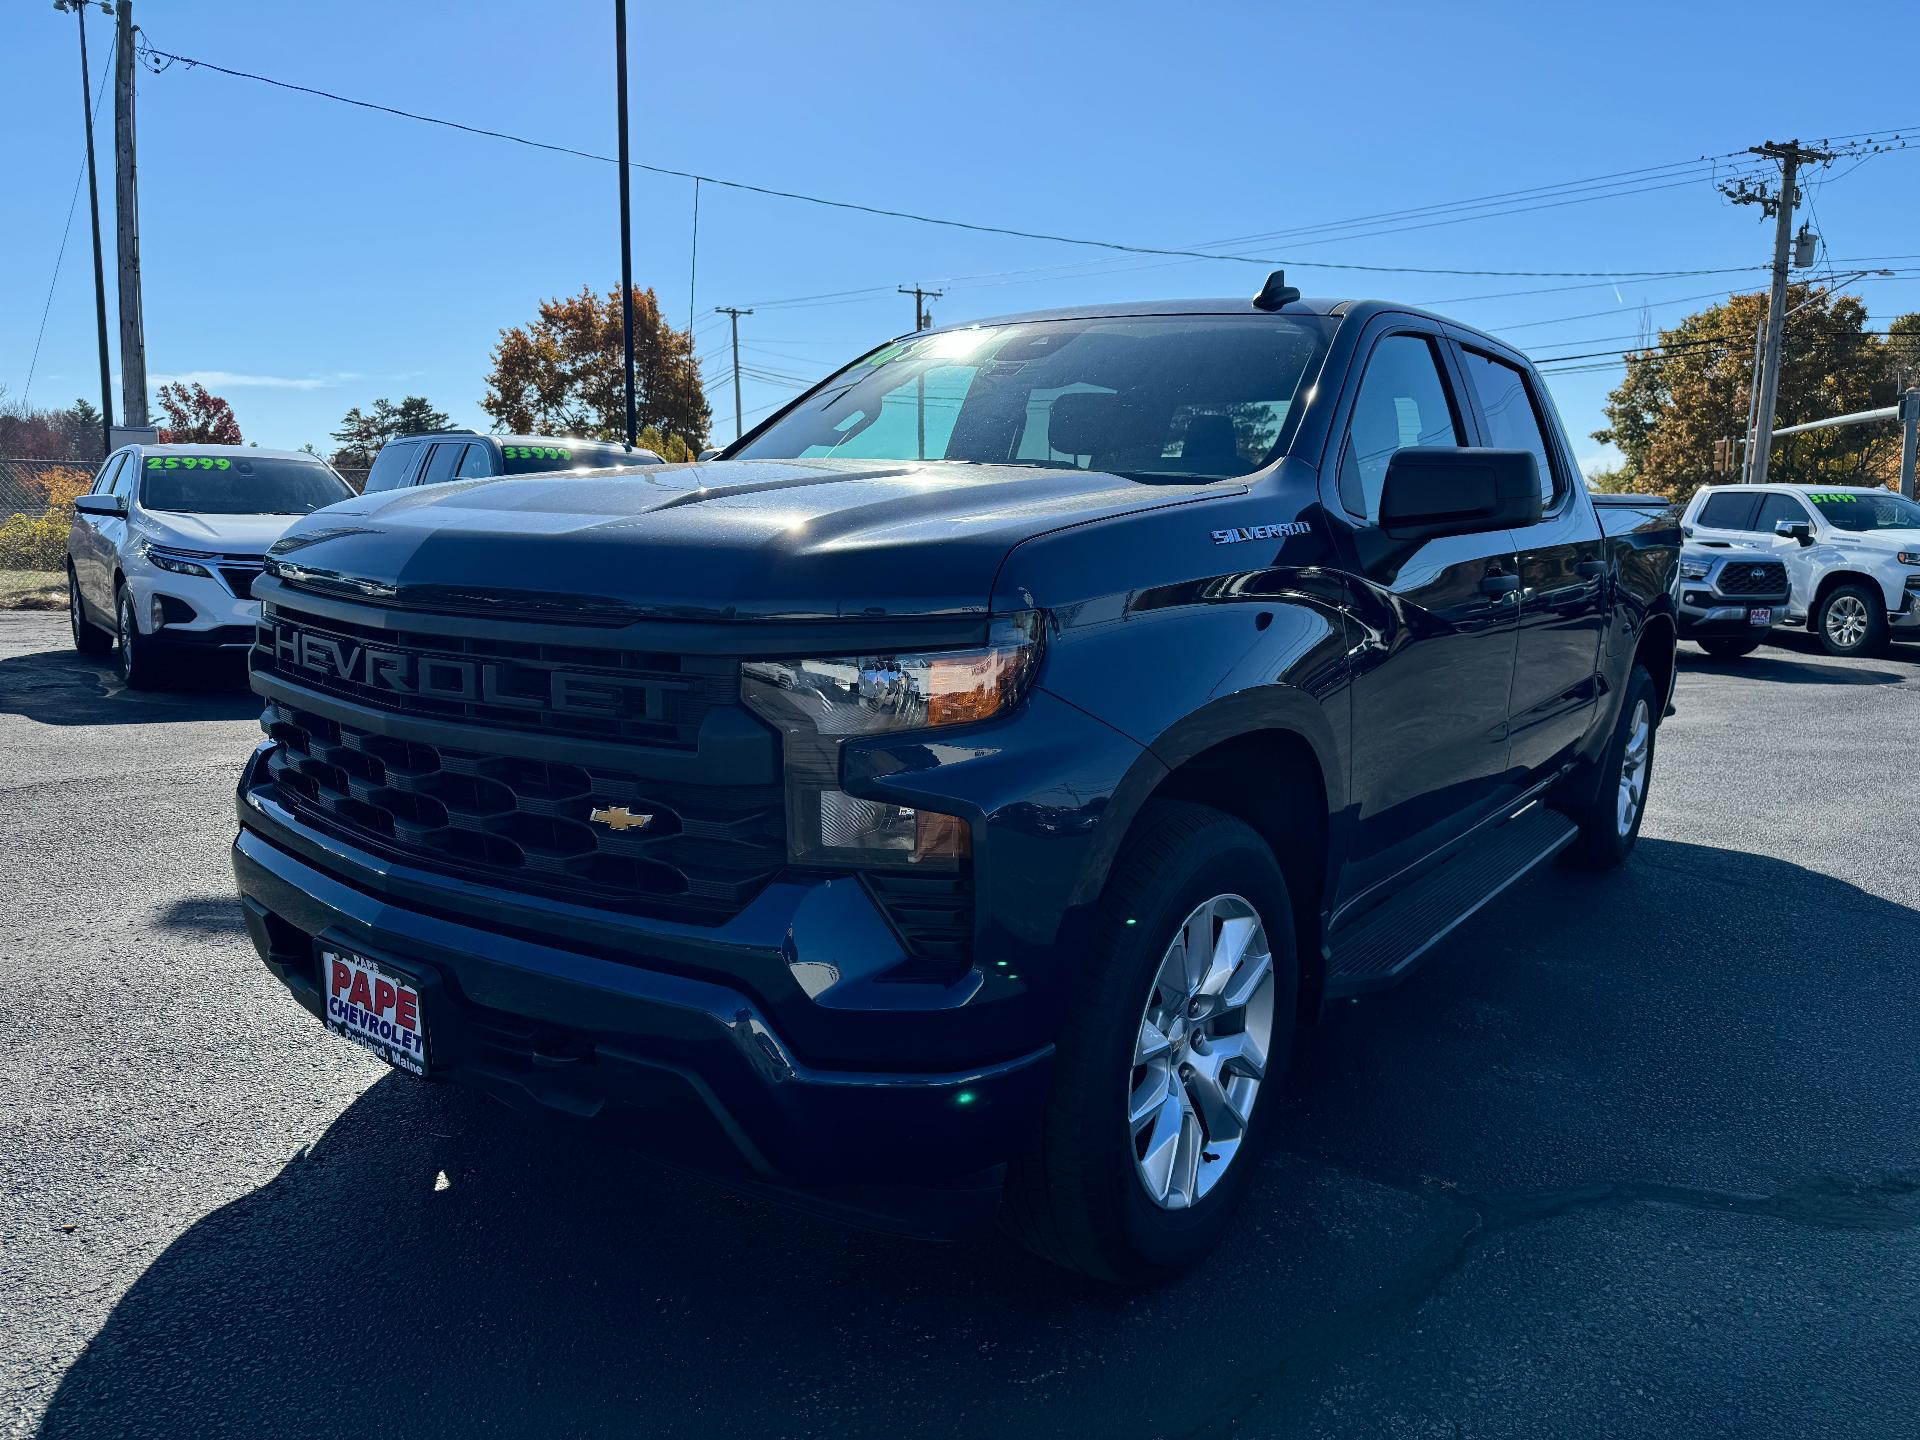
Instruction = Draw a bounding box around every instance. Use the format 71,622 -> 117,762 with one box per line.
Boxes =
67,445 -> 353,689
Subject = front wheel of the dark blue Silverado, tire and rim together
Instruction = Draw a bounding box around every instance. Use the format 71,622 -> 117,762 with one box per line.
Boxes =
1002,801 -> 1298,1284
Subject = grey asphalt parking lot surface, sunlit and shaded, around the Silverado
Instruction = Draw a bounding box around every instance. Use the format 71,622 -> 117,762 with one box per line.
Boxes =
0,612 -> 1920,1438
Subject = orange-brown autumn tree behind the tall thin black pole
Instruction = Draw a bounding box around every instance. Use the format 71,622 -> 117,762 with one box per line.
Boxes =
480,286 -> 712,449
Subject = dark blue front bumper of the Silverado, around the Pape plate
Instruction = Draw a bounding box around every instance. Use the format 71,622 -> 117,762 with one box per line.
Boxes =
232,766 -> 1052,1231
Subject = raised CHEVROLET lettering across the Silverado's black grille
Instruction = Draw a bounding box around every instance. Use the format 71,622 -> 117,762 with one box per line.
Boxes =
273,622 -> 693,720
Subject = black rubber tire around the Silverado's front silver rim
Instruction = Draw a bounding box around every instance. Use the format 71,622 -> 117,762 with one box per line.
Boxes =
1002,801 -> 1300,1284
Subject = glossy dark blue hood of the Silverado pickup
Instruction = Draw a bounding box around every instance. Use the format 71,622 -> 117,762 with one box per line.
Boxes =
271,459 -> 1244,622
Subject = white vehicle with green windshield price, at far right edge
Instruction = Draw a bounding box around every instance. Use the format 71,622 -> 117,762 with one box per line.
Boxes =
1682,486 -> 1920,655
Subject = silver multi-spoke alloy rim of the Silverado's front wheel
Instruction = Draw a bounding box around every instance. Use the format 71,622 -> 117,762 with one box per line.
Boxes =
1127,895 -> 1273,1210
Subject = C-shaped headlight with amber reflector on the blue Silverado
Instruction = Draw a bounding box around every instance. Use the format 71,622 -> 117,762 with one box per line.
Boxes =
739,616 -> 1039,868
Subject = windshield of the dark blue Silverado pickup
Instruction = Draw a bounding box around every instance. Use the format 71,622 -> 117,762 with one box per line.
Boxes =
730,315 -> 1336,480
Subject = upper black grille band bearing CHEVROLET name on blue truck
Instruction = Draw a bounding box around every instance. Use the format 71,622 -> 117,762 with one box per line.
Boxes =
253,603 -> 739,749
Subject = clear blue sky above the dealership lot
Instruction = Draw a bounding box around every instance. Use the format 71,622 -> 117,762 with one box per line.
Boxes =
0,0 -> 1920,468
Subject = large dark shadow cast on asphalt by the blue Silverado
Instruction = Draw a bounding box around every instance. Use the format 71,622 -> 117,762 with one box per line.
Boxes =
26,839 -> 1920,1436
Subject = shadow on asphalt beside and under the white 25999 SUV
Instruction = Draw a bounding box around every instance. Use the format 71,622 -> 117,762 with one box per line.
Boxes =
0,651 -> 259,726
